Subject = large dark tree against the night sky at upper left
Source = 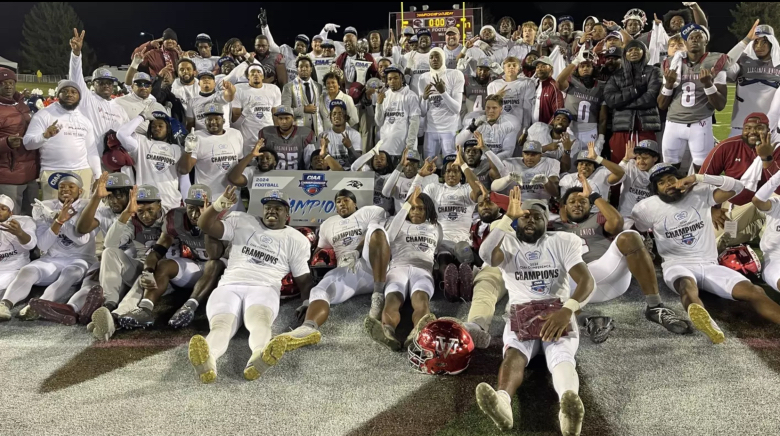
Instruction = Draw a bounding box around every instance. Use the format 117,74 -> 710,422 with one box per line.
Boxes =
20,2 -> 97,75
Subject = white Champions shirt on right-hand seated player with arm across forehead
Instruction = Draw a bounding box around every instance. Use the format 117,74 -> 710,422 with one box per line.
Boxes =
631,184 -> 718,268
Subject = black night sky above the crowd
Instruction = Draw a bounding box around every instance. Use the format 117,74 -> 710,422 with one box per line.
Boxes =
0,2 -> 737,69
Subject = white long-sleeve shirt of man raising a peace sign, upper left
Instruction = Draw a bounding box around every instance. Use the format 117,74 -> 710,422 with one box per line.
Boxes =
68,52 -> 128,156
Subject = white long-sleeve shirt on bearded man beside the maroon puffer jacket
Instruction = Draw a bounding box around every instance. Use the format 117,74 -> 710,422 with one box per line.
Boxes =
24,102 -> 101,178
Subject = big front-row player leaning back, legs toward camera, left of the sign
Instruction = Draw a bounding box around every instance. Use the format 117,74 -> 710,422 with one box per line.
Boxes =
189,186 -> 319,383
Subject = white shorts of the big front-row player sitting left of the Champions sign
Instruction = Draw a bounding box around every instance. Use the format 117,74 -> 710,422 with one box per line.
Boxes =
206,285 -> 281,321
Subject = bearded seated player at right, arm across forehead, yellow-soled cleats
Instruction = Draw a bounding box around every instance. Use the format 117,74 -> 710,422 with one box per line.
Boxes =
632,163 -> 780,344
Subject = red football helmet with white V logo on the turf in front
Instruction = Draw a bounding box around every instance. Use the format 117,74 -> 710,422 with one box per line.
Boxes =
409,318 -> 474,375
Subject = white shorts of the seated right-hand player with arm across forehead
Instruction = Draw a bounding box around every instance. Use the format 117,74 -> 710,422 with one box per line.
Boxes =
664,263 -> 748,300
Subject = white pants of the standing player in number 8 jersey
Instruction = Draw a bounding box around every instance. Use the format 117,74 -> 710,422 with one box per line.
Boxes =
663,118 -> 715,165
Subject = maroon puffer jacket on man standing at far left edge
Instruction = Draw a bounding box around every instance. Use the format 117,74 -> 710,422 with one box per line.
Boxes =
0,92 -> 41,185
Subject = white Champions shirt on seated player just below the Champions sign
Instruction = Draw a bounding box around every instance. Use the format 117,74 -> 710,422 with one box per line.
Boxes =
317,206 -> 387,259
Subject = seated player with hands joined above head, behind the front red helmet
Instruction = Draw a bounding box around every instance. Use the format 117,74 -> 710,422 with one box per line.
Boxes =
365,187 -> 443,351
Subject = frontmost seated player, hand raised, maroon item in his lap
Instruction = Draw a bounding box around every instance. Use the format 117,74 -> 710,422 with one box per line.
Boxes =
476,187 -> 595,435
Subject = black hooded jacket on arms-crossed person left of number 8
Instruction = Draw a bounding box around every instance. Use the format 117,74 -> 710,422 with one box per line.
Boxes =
604,40 -> 663,132
